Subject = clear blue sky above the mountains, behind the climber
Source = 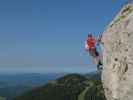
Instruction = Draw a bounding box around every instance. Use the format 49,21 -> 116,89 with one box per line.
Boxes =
0,0 -> 126,72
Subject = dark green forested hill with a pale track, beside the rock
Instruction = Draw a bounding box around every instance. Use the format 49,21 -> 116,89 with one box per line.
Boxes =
13,73 -> 105,100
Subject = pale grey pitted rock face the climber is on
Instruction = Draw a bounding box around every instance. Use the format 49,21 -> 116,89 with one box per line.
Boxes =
102,2 -> 133,100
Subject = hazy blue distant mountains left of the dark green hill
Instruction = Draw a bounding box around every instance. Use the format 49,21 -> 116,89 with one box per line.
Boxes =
0,73 -> 64,100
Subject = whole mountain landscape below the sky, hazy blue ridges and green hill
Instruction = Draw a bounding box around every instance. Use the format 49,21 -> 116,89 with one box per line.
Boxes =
0,72 -> 105,100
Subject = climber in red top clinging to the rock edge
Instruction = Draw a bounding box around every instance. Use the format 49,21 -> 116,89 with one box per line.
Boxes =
85,33 -> 102,70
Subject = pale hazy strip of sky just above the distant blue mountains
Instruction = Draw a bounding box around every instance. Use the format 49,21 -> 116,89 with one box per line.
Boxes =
0,67 -> 96,74
